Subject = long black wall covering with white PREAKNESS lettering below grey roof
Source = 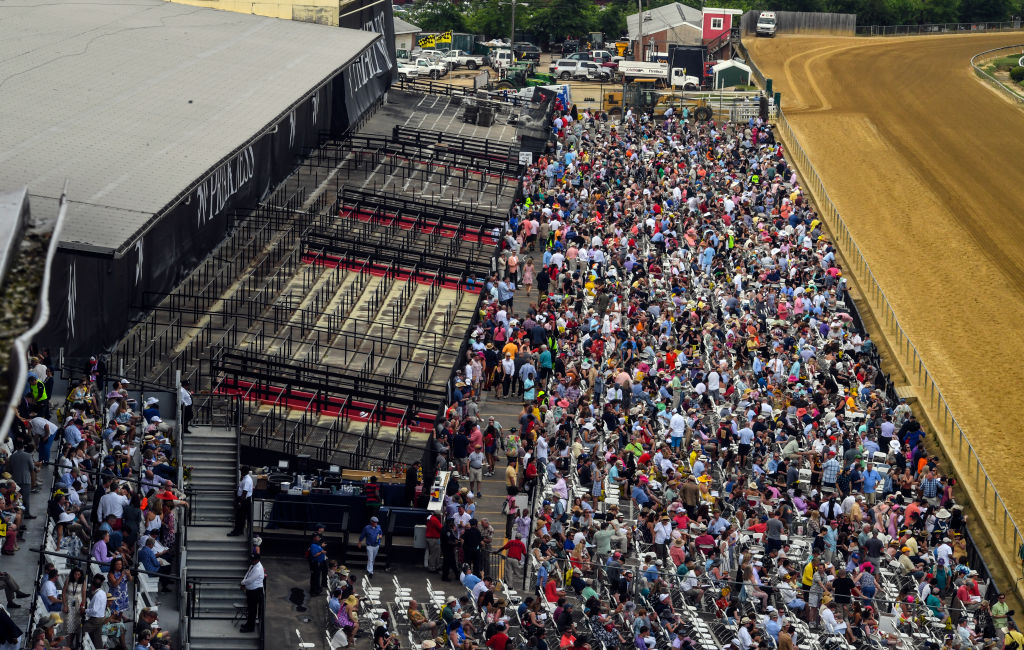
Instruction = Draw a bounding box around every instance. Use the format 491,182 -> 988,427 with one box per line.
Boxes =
38,72 -> 344,360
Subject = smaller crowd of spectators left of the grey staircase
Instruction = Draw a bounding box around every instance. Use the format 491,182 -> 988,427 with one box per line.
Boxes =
0,351 -> 185,649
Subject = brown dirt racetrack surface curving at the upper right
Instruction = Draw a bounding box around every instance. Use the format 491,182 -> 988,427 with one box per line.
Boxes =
746,33 -> 1024,525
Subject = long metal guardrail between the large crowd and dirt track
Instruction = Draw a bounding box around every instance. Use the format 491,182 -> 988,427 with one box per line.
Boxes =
776,105 -> 1024,594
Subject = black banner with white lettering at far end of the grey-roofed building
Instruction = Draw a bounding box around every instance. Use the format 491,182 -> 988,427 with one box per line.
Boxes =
332,0 -> 397,134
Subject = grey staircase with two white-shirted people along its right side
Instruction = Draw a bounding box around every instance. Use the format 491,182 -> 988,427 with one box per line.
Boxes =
182,425 -> 260,650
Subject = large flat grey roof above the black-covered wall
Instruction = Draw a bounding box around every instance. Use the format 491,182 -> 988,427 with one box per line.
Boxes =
0,0 -> 378,252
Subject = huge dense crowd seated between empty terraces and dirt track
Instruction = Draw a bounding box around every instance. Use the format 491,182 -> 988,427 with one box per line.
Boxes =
413,109 -> 1024,650
